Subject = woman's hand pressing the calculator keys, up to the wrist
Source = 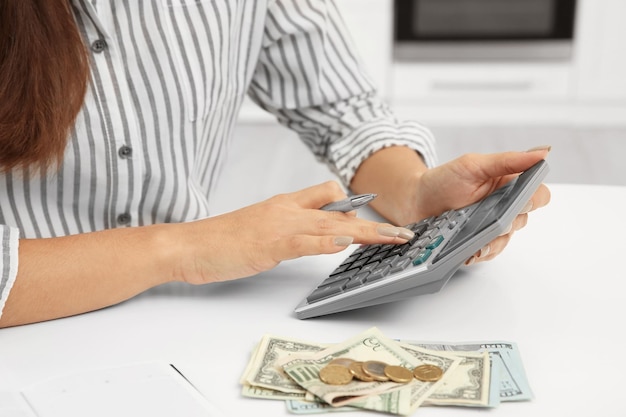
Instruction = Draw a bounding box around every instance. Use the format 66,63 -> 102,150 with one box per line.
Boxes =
174,182 -> 413,284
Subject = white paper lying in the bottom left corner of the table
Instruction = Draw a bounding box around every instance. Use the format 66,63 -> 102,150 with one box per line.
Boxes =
0,363 -> 225,417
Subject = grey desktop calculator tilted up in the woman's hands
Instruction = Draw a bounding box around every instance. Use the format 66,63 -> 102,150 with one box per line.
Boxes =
295,160 -> 549,319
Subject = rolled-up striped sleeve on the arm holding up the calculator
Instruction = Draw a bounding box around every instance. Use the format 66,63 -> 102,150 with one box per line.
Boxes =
248,0 -> 437,186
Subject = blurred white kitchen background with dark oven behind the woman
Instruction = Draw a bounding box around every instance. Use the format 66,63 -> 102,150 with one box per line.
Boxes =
215,0 -> 626,211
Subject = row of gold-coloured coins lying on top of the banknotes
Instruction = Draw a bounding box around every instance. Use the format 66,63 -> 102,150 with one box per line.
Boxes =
320,358 -> 443,385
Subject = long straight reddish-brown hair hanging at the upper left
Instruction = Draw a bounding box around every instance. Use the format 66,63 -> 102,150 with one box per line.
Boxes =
0,0 -> 89,171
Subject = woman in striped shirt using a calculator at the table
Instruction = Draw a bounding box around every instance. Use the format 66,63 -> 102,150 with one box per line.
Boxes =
0,0 -> 549,326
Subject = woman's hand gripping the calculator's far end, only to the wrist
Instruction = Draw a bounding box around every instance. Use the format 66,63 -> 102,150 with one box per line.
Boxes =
416,147 -> 550,265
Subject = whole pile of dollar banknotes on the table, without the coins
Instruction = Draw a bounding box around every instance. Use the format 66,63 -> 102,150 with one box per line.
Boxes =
240,328 -> 532,415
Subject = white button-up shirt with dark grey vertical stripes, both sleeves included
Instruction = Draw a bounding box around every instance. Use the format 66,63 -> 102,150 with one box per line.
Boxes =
0,0 -> 435,318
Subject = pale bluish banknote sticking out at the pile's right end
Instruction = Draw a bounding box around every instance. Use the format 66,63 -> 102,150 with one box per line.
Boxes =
405,341 -> 533,405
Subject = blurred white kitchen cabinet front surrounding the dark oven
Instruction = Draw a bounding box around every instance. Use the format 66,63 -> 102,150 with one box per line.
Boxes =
243,0 -> 626,126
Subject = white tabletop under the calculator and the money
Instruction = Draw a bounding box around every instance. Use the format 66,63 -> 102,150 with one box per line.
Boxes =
0,185 -> 626,416
